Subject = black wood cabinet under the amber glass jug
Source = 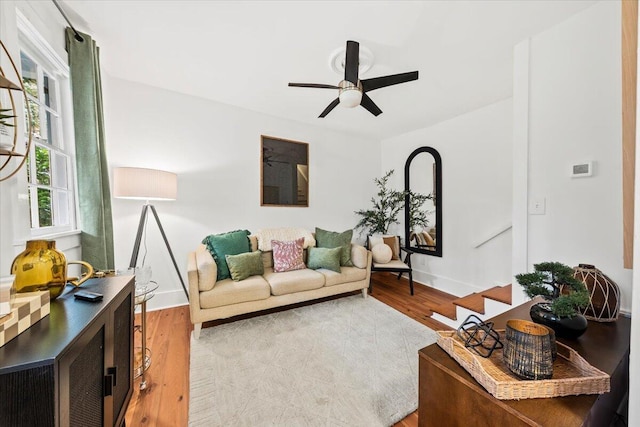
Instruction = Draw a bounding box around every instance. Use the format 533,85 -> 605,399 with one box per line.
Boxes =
0,276 -> 134,427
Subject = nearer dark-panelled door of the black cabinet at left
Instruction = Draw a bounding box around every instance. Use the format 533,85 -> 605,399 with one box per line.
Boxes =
59,313 -> 108,427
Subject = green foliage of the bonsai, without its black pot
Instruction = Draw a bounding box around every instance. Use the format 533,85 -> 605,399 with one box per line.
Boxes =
516,262 -> 589,317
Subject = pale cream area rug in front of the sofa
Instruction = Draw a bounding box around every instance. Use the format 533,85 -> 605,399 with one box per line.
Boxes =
189,295 -> 436,427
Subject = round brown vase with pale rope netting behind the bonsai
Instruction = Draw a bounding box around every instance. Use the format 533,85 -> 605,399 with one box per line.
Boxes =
573,264 -> 620,322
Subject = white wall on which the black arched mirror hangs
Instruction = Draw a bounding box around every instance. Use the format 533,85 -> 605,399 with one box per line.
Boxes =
381,99 -> 512,296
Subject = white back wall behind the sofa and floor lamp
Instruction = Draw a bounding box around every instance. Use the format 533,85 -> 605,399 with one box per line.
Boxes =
104,78 -> 380,308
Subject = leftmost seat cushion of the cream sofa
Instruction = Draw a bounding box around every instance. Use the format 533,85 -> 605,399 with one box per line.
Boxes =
200,276 -> 271,308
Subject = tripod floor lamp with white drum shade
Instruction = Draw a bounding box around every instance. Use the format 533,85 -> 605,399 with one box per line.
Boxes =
113,168 -> 189,300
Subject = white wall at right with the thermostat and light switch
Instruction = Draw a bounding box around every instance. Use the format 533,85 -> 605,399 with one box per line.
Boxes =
514,2 -> 631,311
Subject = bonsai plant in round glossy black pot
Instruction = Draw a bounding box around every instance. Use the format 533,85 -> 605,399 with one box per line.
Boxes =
516,262 -> 589,337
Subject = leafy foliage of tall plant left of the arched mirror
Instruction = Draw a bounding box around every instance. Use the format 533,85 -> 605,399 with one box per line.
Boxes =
355,169 -> 404,234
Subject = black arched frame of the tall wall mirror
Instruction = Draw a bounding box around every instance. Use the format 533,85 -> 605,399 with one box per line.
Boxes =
404,147 -> 442,257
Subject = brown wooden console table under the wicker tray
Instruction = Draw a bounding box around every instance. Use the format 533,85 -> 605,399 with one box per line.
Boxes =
418,302 -> 631,427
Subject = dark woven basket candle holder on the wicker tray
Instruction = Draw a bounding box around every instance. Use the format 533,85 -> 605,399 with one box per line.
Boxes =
503,319 -> 555,380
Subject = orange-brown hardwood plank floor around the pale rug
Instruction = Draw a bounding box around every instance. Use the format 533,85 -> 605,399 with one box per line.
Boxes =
125,272 -> 455,427
